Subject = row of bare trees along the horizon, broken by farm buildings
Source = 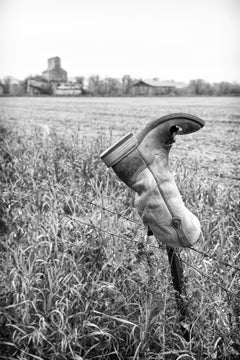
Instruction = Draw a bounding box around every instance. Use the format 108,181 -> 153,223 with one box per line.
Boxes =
0,75 -> 240,96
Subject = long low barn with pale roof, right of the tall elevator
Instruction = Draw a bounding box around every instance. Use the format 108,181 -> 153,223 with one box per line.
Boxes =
132,79 -> 185,96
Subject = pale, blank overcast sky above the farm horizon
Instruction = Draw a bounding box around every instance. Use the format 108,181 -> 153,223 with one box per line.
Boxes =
0,0 -> 240,82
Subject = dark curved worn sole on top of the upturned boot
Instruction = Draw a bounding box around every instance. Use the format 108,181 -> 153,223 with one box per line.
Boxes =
136,113 -> 205,144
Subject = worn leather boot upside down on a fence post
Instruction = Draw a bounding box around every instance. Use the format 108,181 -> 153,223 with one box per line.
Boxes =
101,113 -> 204,247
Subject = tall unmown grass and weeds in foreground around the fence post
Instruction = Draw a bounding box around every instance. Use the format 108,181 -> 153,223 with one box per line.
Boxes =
0,123 -> 240,360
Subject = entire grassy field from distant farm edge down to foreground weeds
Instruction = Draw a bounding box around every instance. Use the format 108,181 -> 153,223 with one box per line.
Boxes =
0,97 -> 240,360
